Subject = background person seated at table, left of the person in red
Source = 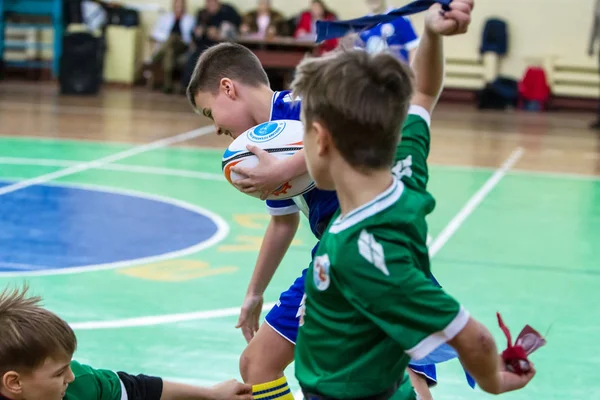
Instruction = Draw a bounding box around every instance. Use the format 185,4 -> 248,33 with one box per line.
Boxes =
240,0 -> 286,38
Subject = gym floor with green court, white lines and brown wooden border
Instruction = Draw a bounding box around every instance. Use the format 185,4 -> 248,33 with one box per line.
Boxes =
0,82 -> 600,400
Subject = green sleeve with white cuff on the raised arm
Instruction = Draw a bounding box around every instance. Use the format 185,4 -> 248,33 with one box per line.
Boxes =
392,105 -> 431,189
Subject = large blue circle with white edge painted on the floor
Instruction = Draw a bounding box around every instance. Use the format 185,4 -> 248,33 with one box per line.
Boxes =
0,181 -> 219,273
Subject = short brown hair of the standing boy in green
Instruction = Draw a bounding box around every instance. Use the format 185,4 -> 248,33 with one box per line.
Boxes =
292,49 -> 413,169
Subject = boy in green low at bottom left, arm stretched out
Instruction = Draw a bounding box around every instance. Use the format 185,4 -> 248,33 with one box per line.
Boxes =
0,289 -> 252,400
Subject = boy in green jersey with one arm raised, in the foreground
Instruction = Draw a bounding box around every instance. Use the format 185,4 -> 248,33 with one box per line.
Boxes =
292,0 -> 535,400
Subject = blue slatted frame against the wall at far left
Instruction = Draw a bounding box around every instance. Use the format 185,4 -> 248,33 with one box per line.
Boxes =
0,0 -> 64,78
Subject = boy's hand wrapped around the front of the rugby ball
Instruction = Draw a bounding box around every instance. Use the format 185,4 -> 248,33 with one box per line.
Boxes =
231,145 -> 285,200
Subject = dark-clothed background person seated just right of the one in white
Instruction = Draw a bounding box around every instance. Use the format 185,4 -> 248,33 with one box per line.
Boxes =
181,0 -> 242,88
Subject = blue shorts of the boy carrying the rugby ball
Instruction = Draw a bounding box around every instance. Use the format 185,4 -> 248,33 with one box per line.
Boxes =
265,269 -> 474,387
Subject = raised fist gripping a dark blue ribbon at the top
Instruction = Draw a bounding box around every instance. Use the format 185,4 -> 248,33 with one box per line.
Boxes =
425,0 -> 475,36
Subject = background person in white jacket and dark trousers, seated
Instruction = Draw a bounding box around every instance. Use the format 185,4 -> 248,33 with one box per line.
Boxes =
149,0 -> 194,93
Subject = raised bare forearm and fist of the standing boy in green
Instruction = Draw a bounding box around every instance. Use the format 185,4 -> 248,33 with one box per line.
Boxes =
412,0 -> 474,114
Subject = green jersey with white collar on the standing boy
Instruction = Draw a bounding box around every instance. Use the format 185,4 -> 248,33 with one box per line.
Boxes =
295,109 -> 469,399
